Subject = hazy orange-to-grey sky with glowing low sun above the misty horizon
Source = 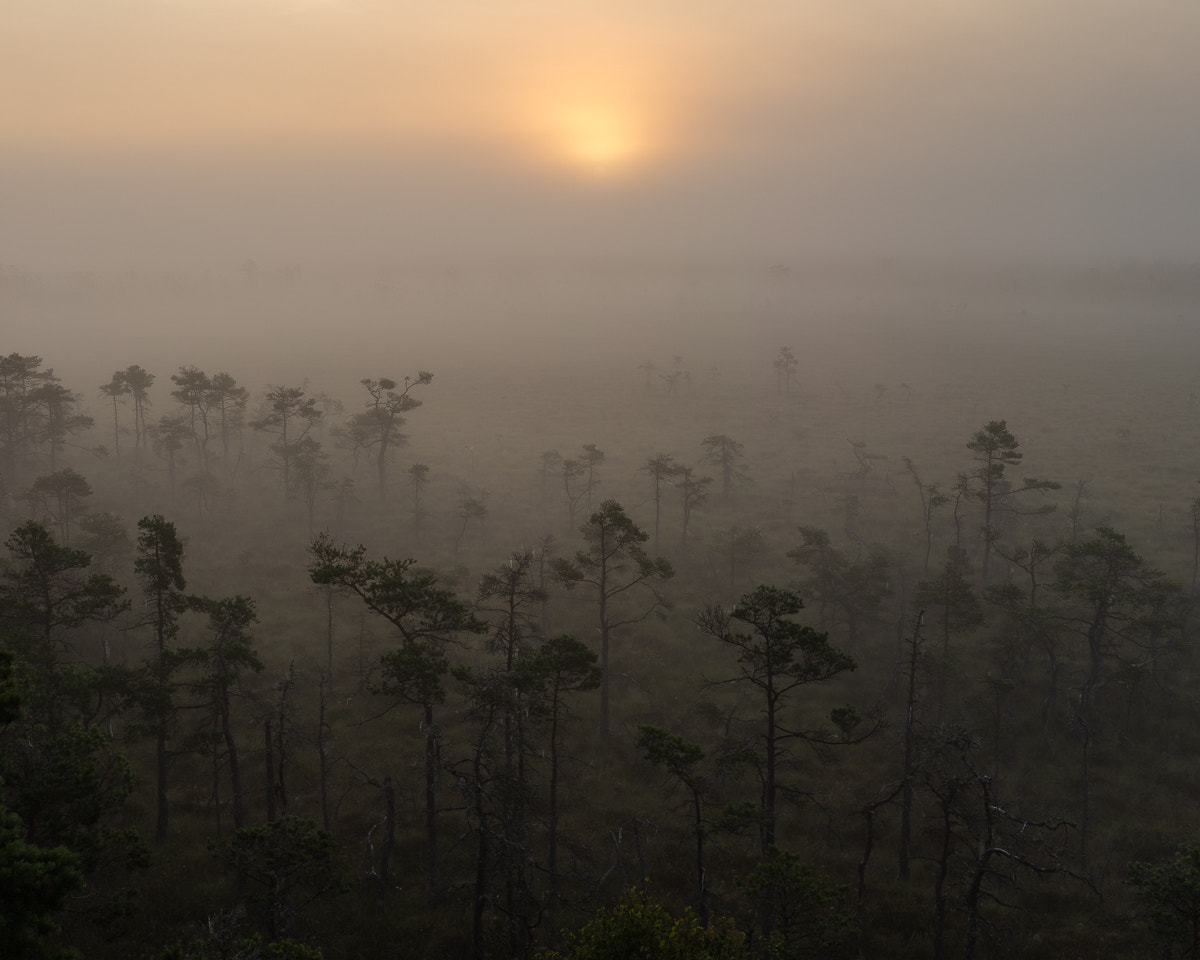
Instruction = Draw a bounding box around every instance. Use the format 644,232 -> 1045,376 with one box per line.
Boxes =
0,0 -> 1200,270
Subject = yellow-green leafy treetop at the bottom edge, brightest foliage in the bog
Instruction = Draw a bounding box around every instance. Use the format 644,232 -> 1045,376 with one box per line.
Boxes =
539,890 -> 746,960
